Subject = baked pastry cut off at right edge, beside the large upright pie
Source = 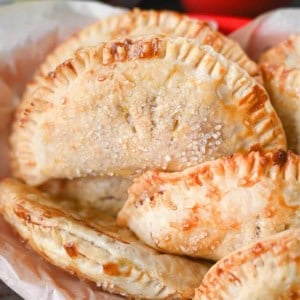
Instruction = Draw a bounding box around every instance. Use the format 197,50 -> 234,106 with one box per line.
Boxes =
260,35 -> 300,154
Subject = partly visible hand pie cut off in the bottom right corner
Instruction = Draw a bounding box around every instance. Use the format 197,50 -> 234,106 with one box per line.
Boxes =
194,229 -> 300,300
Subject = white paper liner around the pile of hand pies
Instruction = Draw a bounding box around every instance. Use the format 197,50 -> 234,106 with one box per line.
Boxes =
0,1 -> 300,300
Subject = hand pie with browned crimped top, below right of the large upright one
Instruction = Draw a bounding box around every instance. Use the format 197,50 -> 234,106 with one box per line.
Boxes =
118,151 -> 300,260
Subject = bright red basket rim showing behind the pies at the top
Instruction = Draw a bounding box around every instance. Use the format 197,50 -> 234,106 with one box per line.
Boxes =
189,14 -> 251,34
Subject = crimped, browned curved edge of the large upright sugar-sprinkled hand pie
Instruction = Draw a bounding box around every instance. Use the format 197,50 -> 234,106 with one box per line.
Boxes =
11,35 -> 286,185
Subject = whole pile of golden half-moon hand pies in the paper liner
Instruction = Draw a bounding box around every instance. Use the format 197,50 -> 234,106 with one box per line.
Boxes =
0,10 -> 300,300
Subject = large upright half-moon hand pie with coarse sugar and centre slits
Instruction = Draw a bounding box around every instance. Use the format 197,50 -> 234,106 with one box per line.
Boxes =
11,36 -> 286,185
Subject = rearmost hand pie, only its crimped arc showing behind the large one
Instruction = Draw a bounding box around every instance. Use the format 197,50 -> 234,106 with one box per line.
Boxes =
32,9 -> 259,80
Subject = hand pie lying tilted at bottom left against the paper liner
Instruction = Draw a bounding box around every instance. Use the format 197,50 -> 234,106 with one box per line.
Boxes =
0,179 -> 210,299
